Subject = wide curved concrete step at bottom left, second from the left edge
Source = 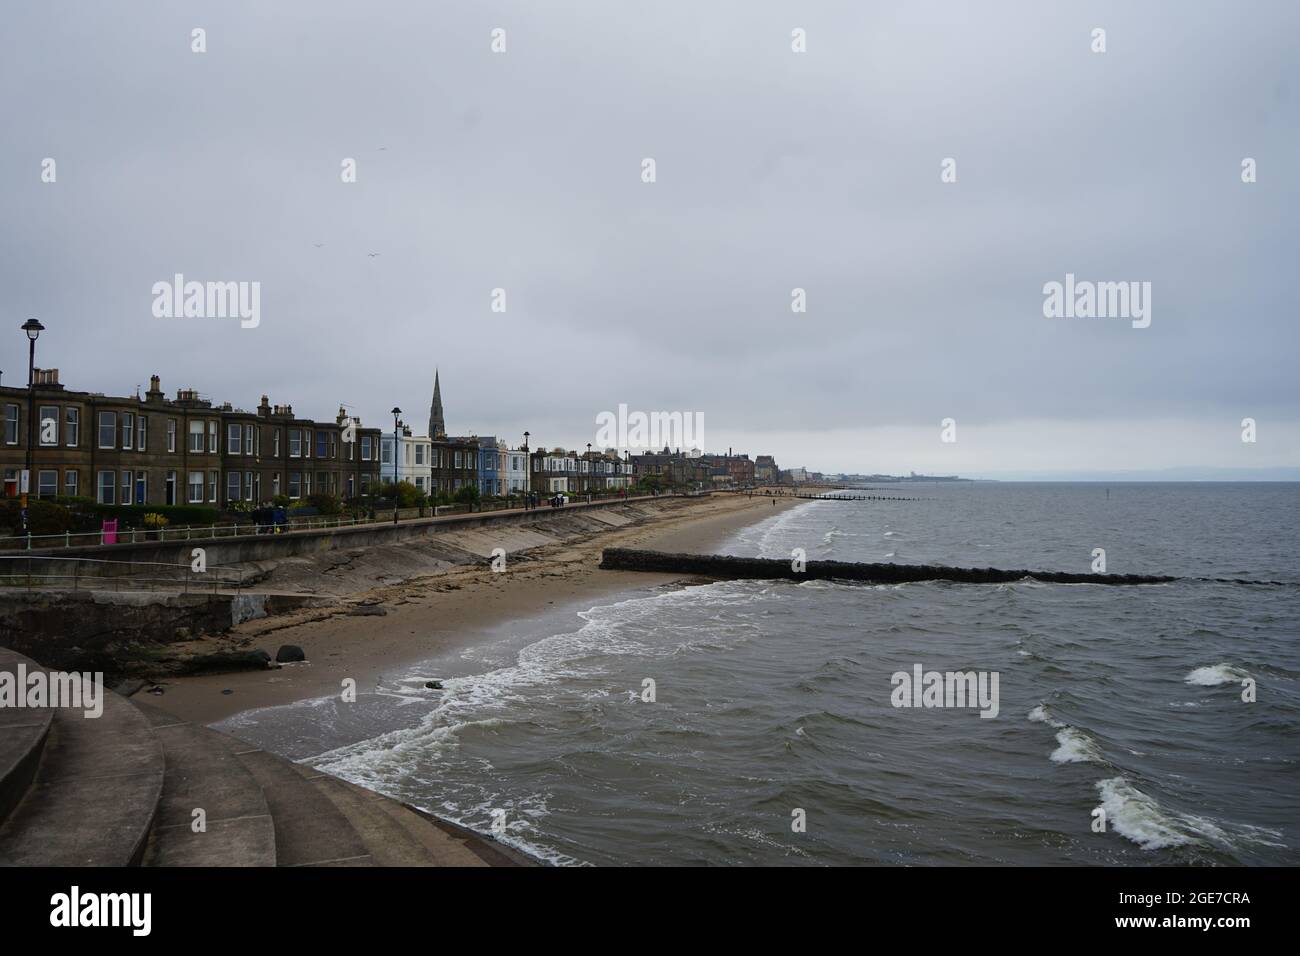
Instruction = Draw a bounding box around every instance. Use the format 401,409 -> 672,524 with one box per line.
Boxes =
0,671 -> 164,866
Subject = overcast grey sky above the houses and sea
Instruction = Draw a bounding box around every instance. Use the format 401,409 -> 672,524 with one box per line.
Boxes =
0,0 -> 1300,479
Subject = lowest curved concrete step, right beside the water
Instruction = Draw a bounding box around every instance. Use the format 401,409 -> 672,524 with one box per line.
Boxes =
294,763 -> 491,866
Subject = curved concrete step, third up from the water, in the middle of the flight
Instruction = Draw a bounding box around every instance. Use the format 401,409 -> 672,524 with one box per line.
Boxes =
131,700 -> 276,866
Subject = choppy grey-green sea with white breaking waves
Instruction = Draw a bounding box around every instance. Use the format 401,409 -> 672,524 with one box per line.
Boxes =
216,481 -> 1300,866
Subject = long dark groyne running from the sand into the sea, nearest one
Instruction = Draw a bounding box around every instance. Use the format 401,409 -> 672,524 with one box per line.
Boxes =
601,548 -> 1178,584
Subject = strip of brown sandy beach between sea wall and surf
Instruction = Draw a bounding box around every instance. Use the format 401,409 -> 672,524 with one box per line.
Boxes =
147,494 -> 801,723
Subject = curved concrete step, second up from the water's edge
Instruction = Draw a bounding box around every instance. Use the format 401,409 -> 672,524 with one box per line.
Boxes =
228,737 -> 376,866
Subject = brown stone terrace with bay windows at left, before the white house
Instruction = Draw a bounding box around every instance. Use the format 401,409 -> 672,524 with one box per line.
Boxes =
0,368 -> 380,507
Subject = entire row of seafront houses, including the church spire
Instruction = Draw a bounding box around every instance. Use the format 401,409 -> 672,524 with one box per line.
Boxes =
0,369 -> 779,507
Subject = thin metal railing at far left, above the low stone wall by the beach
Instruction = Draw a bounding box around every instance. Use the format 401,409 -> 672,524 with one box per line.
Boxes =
0,554 -> 246,594
